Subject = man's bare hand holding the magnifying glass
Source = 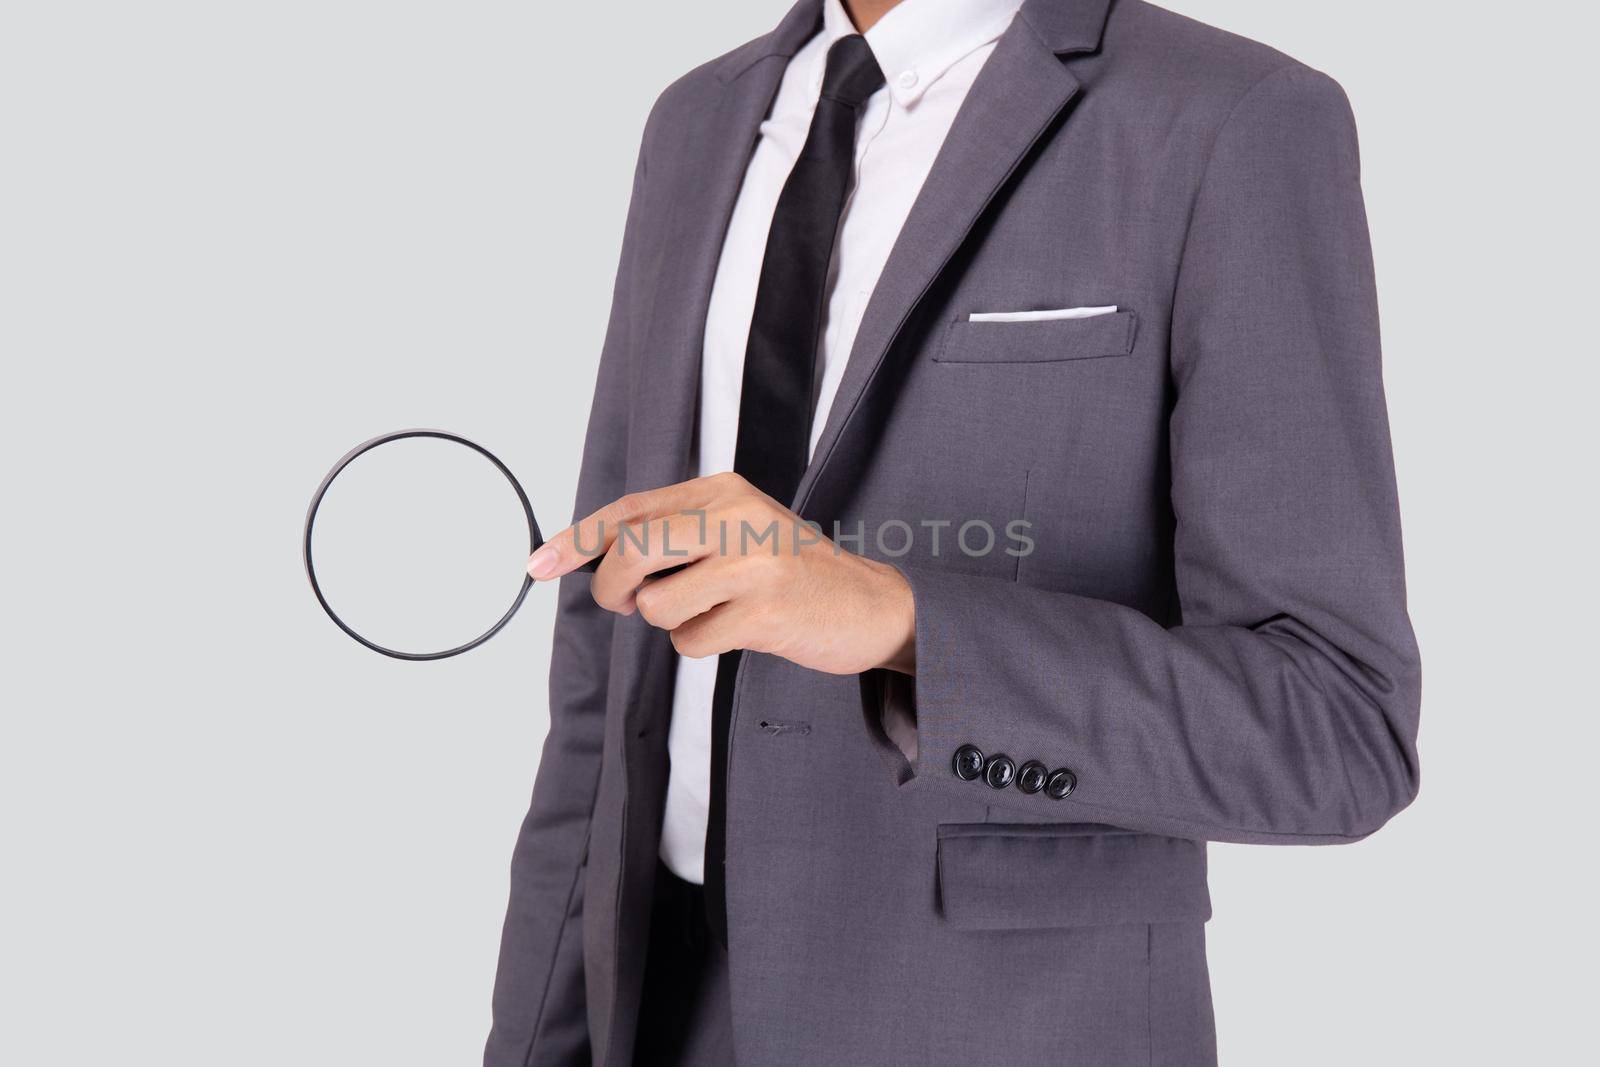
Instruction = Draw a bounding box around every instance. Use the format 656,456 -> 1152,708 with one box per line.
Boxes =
528,474 -> 915,673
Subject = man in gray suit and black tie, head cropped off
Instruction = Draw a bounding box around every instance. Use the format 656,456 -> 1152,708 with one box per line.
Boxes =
485,0 -> 1419,1067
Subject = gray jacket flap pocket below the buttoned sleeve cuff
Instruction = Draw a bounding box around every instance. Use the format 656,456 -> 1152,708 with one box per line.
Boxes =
938,822 -> 1211,929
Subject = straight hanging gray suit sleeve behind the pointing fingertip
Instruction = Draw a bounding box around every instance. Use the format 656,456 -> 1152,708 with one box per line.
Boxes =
483,137 -> 645,1067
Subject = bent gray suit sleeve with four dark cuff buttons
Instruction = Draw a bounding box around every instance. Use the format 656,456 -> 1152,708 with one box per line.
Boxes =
907,66 -> 1421,843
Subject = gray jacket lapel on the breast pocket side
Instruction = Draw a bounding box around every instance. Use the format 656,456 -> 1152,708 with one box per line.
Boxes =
795,8 -> 1098,518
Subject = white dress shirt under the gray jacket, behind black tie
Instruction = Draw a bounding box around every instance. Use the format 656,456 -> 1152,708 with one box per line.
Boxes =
661,0 -> 1021,883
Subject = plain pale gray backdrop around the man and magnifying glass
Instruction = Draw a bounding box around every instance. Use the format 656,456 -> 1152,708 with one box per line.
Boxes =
0,0 -> 1600,1065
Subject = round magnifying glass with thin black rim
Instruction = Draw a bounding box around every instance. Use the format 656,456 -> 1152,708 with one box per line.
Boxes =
302,429 -> 560,661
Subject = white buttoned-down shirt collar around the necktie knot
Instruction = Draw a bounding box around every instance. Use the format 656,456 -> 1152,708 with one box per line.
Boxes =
813,0 -> 1022,107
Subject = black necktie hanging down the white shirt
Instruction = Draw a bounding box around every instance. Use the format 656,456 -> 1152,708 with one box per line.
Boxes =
706,34 -> 883,944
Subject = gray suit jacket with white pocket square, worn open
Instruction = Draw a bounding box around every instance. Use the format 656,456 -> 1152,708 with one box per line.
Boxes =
485,0 -> 1419,1067
